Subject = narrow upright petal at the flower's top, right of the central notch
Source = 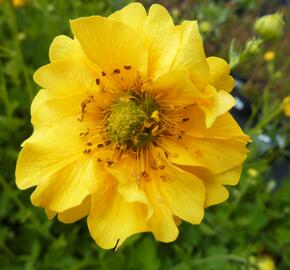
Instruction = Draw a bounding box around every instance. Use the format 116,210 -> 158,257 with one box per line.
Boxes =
144,4 -> 180,79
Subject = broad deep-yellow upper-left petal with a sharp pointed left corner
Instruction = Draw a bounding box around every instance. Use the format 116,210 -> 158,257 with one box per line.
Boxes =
71,16 -> 148,78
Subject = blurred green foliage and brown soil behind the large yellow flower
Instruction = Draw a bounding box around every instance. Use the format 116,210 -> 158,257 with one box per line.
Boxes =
0,0 -> 290,270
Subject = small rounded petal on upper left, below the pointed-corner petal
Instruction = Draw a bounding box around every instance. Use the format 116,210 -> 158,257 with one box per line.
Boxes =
33,60 -> 98,96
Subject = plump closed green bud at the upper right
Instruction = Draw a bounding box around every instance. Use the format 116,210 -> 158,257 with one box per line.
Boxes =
254,12 -> 285,40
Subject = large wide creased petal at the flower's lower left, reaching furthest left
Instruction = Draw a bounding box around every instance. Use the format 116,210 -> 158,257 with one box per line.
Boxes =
16,118 -> 105,212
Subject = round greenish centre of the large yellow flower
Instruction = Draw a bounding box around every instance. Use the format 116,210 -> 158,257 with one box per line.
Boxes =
106,95 -> 158,150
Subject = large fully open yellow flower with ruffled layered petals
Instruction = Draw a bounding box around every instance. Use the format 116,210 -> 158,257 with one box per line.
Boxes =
16,3 -> 249,248
